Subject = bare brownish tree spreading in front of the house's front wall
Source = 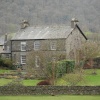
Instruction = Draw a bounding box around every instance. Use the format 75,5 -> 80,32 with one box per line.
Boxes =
26,48 -> 64,85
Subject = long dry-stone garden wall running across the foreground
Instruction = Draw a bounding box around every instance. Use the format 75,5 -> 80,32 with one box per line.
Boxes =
0,86 -> 100,95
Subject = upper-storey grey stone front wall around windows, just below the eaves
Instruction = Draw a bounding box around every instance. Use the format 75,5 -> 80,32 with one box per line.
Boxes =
12,39 -> 65,52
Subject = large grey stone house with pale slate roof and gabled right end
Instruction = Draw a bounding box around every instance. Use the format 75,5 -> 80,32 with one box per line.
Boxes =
0,19 -> 87,68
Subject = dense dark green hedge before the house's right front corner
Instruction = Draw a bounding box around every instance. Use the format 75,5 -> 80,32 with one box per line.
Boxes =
47,60 -> 75,78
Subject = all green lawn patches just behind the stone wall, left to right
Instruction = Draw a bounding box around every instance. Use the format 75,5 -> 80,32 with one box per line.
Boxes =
0,69 -> 100,86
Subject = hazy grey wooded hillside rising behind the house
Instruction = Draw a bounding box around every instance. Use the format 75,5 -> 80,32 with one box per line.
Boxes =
0,0 -> 100,34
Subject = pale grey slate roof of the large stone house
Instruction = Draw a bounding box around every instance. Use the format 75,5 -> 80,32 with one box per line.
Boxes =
11,26 -> 72,40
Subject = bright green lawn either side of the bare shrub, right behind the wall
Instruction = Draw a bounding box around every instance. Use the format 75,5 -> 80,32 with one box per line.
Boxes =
57,69 -> 100,86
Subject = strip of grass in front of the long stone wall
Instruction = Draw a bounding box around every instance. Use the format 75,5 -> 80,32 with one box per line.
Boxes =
0,95 -> 100,100
